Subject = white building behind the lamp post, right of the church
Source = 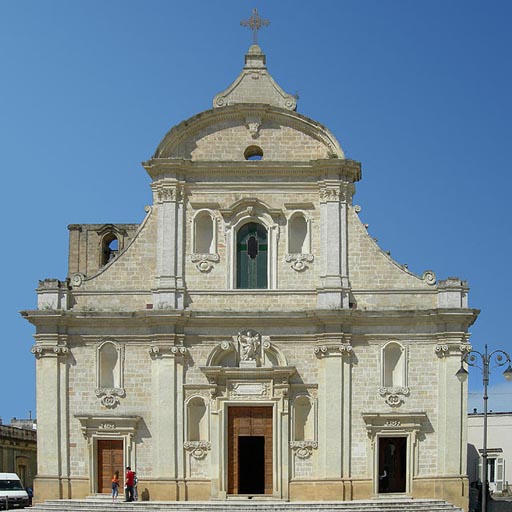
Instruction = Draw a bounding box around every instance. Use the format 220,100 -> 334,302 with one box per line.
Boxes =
468,412 -> 512,495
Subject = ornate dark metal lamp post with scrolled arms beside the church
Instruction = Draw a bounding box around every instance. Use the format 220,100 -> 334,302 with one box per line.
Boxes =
456,345 -> 512,512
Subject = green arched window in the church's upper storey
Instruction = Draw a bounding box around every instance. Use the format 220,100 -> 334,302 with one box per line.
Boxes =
236,222 -> 268,288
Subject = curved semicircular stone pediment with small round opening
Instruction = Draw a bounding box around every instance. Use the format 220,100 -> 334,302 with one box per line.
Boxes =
154,104 -> 345,162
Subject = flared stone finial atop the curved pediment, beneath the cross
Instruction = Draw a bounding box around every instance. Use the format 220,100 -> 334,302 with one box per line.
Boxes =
213,44 -> 297,110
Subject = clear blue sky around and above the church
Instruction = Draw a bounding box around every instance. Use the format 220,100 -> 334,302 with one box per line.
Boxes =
0,0 -> 512,422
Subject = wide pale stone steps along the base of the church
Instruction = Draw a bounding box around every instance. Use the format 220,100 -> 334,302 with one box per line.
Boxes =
32,495 -> 462,512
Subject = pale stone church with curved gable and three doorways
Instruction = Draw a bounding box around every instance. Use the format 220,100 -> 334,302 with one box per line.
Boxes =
22,35 -> 478,507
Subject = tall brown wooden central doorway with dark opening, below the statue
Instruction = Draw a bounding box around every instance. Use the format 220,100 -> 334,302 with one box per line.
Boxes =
228,407 -> 272,494
